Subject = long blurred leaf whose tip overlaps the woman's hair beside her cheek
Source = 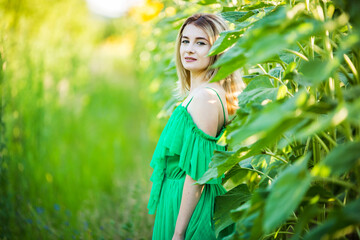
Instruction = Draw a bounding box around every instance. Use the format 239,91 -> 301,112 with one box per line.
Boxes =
213,4 -> 323,81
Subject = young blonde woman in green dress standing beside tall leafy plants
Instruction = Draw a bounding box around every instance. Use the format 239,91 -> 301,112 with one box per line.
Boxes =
148,14 -> 239,240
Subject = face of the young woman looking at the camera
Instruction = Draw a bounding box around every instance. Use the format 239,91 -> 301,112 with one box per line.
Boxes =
180,24 -> 211,73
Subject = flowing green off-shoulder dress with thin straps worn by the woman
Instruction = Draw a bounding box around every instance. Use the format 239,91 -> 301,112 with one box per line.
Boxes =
148,89 -> 232,240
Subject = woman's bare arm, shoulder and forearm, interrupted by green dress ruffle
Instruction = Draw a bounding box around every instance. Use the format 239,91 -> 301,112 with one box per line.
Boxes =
173,89 -> 219,240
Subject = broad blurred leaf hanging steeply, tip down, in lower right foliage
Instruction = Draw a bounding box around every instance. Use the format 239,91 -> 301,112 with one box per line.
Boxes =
263,156 -> 311,232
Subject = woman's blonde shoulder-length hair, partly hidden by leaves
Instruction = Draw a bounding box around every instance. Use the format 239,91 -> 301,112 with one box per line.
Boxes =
175,13 -> 241,115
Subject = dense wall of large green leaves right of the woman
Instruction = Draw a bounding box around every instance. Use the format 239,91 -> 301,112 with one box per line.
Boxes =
194,1 -> 360,239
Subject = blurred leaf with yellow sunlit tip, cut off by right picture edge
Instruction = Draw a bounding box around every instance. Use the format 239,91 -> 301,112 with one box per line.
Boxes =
311,142 -> 360,177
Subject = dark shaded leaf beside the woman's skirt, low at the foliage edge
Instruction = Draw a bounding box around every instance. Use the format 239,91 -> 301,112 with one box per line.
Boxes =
214,184 -> 251,235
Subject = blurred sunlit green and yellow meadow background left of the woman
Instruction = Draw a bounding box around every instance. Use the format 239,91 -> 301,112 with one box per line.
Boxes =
0,0 -> 211,239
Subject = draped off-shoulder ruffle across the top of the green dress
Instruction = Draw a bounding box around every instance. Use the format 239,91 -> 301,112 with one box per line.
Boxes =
148,105 -> 225,214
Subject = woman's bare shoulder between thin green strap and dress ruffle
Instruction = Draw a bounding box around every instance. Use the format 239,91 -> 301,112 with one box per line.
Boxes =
188,88 -> 219,136
